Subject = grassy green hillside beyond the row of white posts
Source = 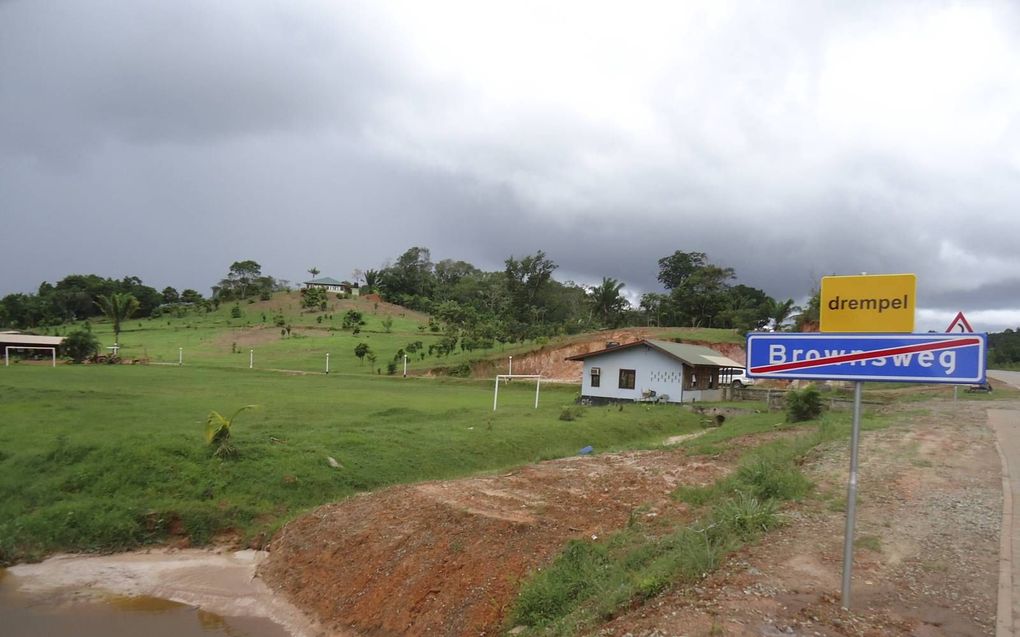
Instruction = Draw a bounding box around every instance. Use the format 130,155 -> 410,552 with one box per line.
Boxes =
29,293 -> 744,375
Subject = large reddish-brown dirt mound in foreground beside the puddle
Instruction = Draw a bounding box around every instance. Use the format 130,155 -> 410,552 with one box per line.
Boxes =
260,450 -> 724,635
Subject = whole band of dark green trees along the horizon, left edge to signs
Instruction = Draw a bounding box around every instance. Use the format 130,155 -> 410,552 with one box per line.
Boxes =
0,247 -> 797,356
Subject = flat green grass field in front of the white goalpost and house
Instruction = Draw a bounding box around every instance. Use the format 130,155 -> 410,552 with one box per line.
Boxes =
0,365 -> 699,564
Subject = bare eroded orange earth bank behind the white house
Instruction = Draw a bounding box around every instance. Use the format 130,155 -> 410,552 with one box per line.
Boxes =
472,327 -> 745,382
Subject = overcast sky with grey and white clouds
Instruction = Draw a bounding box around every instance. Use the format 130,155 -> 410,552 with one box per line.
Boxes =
0,0 -> 1020,331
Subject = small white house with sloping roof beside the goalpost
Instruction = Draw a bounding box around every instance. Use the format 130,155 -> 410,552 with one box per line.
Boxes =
567,339 -> 743,403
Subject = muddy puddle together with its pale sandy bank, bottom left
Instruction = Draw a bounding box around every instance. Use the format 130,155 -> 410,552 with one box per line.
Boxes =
0,549 -> 319,637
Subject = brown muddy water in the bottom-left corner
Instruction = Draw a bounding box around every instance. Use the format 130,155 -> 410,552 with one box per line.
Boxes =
0,569 -> 288,637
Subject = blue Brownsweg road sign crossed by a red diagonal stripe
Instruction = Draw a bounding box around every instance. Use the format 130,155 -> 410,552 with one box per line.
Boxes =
748,332 -> 987,384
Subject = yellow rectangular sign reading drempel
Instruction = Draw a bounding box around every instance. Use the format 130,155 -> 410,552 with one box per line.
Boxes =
819,274 -> 917,332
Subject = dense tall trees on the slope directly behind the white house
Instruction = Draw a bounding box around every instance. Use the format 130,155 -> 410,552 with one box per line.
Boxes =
367,247 -> 800,340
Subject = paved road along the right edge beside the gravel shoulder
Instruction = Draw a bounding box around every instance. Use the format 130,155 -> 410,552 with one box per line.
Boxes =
988,370 -> 1020,637
